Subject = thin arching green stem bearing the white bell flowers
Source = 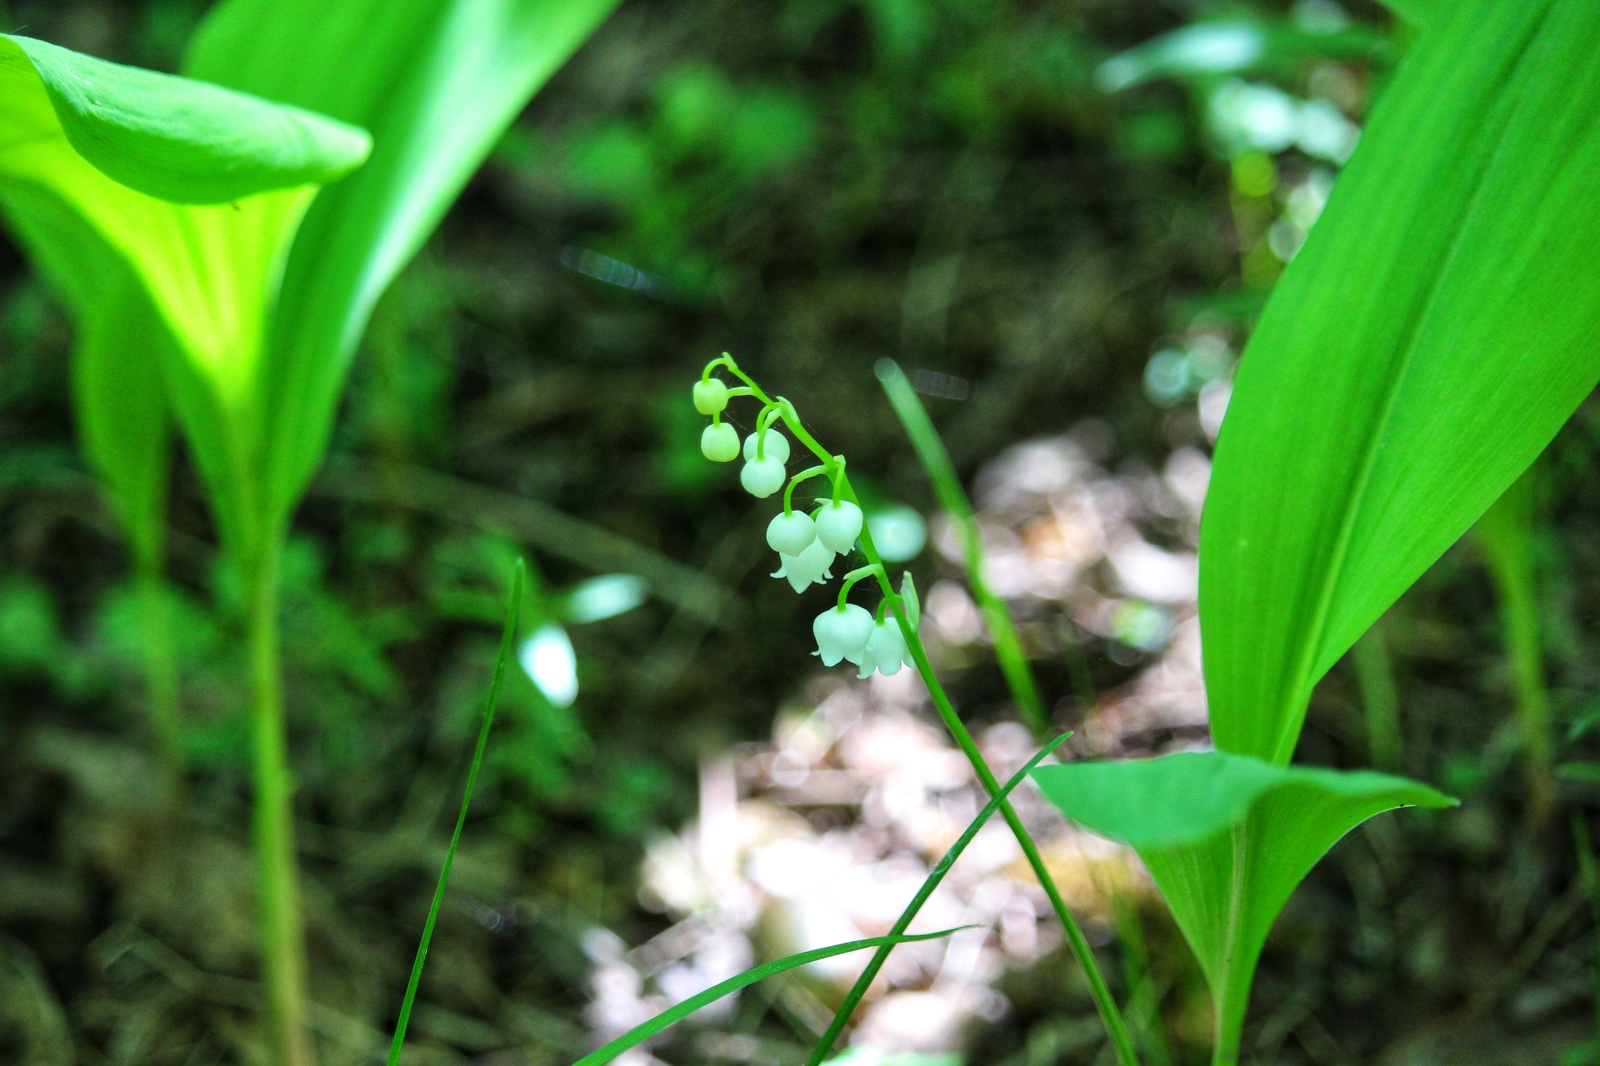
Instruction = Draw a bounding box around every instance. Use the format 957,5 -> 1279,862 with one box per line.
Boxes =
707,352 -> 1139,1066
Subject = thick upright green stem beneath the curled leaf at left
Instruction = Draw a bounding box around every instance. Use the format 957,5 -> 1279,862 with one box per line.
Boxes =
245,538 -> 314,1066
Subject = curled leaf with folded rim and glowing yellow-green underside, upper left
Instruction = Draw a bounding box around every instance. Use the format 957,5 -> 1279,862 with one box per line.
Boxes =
0,37 -> 368,552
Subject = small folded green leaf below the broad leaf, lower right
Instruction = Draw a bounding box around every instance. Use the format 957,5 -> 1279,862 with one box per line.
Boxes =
1034,751 -> 1454,1043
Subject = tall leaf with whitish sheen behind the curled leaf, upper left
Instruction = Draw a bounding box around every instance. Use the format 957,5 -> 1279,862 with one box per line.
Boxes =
187,0 -> 618,522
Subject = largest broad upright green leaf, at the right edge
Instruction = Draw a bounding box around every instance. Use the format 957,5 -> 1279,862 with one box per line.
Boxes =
1200,0 -> 1600,763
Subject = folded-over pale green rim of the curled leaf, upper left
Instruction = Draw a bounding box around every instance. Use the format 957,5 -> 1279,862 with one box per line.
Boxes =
0,35 -> 371,203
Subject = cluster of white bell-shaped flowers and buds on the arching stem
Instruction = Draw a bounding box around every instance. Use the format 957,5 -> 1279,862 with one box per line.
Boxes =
694,354 -> 917,677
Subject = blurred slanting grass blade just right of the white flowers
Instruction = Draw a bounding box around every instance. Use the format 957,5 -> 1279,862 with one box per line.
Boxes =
875,359 -> 1050,736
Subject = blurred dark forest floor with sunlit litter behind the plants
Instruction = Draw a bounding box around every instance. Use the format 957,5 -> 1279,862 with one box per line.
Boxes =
0,0 -> 1600,1066
